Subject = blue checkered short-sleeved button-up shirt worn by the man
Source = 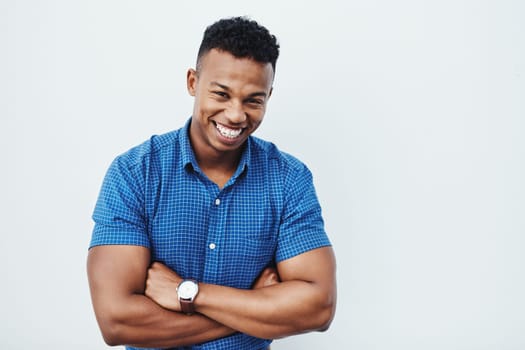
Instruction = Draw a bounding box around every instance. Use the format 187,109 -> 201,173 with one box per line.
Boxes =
90,119 -> 330,350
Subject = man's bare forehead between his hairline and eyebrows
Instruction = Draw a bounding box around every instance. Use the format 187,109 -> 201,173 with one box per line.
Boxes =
194,49 -> 273,88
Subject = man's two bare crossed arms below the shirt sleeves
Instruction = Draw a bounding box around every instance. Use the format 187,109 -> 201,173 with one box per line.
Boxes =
87,245 -> 336,347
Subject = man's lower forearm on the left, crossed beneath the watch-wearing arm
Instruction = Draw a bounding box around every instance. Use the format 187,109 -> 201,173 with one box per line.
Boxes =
97,294 -> 234,348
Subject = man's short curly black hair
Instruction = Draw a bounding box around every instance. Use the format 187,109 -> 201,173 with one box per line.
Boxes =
197,17 -> 279,72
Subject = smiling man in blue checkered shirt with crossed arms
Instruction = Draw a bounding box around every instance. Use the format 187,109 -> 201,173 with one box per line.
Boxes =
88,17 -> 336,350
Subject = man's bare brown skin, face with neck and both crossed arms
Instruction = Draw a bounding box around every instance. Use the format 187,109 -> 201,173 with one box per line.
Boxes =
88,50 -> 336,347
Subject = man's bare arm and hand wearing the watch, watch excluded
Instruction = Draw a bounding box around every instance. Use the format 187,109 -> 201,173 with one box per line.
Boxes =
146,247 -> 336,339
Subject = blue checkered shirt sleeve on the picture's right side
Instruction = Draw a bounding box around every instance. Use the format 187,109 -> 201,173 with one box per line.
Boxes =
275,165 -> 331,262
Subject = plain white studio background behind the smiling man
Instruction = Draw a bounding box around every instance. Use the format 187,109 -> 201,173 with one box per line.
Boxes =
0,0 -> 525,350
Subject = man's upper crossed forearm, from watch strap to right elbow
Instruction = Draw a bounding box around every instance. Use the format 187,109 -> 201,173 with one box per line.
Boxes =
195,280 -> 335,339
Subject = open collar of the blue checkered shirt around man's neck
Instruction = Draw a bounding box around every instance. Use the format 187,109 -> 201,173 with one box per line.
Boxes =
179,117 -> 253,183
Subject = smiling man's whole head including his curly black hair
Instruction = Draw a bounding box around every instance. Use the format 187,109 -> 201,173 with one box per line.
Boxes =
187,17 -> 279,159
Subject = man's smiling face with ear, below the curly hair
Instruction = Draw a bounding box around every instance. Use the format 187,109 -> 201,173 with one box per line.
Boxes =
187,49 -> 273,156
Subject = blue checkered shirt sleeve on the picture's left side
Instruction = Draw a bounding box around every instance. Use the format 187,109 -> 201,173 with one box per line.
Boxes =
90,156 -> 150,248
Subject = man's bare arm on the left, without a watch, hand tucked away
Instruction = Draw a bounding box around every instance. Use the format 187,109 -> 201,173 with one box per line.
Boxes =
87,245 -> 234,347
